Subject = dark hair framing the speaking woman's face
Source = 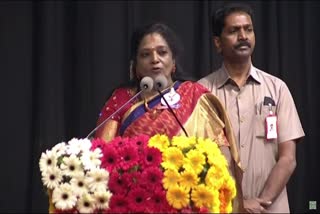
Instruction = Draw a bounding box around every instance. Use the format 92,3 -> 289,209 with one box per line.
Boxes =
130,22 -> 190,86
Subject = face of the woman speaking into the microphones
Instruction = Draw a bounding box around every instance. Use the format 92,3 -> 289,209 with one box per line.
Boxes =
136,33 -> 175,85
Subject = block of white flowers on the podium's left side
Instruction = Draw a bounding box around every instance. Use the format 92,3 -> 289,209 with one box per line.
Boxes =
39,138 -> 112,213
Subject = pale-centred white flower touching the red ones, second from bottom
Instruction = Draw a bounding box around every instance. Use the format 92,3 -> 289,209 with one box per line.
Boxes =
86,168 -> 109,192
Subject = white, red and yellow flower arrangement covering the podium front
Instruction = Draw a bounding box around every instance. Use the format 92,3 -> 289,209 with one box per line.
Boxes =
39,135 -> 236,213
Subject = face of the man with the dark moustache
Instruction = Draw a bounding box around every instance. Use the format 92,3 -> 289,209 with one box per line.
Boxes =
214,12 -> 255,61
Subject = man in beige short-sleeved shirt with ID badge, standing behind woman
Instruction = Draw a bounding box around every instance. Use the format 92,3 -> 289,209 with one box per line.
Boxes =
199,5 -> 304,213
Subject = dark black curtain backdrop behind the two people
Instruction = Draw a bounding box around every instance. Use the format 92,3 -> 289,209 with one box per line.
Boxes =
0,1 -> 320,213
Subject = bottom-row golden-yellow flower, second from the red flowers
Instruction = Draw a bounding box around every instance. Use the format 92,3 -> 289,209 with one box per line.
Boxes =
191,184 -> 219,208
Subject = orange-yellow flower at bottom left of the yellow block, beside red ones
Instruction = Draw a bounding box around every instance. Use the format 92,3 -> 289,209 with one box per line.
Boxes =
166,185 -> 189,209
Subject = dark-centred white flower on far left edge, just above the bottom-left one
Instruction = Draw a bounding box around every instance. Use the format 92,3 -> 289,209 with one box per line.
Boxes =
41,167 -> 62,189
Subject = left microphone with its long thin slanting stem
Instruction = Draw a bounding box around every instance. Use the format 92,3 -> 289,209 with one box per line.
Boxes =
86,76 -> 153,138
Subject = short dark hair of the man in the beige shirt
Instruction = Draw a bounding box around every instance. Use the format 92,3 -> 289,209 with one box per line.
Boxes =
211,3 -> 254,36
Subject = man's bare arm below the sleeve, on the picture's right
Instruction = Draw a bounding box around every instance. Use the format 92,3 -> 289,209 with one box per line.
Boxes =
259,140 -> 297,204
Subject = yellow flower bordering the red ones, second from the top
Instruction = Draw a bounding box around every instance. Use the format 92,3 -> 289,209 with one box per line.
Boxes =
161,147 -> 184,170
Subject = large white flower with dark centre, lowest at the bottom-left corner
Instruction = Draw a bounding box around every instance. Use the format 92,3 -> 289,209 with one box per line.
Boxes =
52,183 -> 77,210
